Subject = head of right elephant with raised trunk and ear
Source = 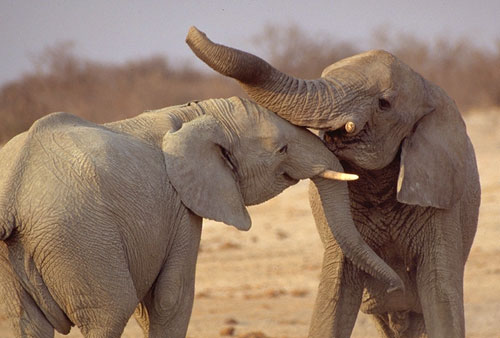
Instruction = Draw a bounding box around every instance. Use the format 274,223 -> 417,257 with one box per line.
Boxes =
186,27 -> 469,208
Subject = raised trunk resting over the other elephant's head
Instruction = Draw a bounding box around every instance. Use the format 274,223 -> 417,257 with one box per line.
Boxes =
186,27 -> 347,129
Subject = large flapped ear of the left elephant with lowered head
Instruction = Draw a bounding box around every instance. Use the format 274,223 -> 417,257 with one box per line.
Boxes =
162,115 -> 251,230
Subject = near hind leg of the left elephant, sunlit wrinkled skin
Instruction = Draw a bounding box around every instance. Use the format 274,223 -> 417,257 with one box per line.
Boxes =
35,222 -> 139,338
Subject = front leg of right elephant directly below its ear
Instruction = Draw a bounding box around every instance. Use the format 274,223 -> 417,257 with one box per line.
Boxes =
417,212 -> 465,338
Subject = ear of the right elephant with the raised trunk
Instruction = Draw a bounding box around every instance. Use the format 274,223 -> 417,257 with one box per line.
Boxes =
397,87 -> 468,209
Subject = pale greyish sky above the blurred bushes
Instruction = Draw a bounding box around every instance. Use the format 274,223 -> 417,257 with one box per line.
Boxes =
0,0 -> 500,85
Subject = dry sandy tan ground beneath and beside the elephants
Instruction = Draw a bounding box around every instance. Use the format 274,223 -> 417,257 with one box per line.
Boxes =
0,111 -> 500,338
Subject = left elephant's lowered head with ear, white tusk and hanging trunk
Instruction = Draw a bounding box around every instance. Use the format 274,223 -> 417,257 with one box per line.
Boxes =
163,98 -> 402,289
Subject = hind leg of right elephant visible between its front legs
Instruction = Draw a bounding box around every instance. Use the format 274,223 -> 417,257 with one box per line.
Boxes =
372,311 -> 427,338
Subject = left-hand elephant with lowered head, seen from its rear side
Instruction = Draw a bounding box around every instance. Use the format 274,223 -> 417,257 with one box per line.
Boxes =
0,98 -> 354,337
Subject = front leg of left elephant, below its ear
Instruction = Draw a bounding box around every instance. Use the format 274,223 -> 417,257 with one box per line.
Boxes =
143,211 -> 201,338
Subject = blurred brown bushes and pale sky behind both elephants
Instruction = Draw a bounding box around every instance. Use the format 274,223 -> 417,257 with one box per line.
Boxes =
0,0 -> 500,144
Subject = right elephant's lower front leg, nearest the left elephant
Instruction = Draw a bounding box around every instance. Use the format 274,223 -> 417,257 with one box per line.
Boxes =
309,243 -> 364,338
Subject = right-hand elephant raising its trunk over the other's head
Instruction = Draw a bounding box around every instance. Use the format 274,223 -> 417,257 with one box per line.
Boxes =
187,28 -> 480,338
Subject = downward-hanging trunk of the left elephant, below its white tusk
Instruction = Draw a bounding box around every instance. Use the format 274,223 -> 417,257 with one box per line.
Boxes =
311,177 -> 404,292
